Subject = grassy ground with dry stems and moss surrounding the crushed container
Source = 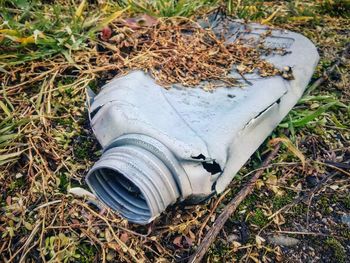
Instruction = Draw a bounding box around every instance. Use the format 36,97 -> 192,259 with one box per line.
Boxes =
0,0 -> 350,262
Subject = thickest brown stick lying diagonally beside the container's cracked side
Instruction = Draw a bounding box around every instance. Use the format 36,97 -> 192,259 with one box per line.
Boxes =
188,144 -> 280,263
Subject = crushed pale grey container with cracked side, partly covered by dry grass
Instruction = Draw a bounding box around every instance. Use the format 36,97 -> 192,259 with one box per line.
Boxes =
87,18 -> 319,224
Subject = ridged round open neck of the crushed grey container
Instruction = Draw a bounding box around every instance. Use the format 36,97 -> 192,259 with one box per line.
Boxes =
86,146 -> 179,224
